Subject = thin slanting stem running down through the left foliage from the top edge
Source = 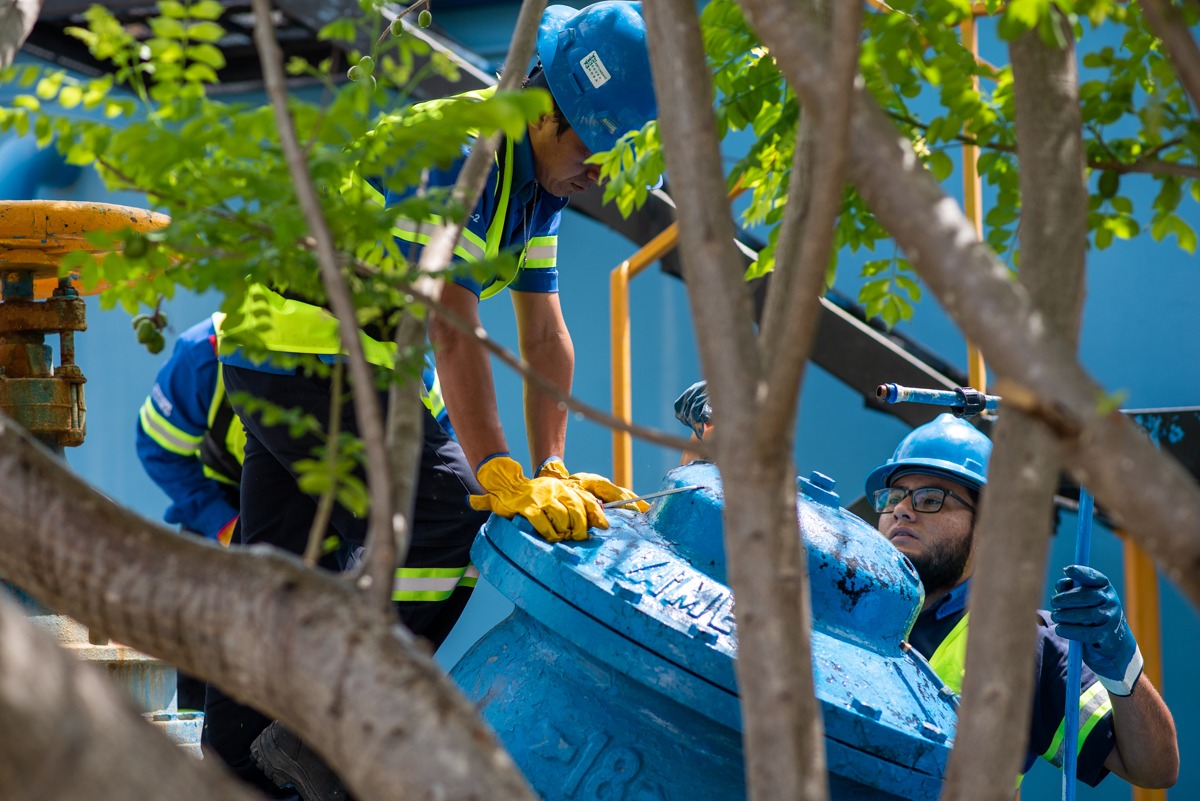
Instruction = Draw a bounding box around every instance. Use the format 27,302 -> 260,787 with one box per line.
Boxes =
251,0 -> 396,609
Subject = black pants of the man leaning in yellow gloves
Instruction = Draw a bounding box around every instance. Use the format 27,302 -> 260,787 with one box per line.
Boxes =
203,365 -> 487,797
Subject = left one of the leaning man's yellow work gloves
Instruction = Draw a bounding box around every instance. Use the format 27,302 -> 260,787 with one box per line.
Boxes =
468,456 -> 608,542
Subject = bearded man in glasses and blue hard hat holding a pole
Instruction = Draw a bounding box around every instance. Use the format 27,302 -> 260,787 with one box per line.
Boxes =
866,414 -> 1180,787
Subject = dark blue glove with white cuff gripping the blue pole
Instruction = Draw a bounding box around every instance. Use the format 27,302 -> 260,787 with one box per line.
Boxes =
1050,565 -> 1142,695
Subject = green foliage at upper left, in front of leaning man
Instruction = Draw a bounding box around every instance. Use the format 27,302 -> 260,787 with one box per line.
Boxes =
0,0 -> 550,511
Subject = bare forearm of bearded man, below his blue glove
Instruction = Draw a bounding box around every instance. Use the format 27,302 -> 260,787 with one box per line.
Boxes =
1104,675 -> 1180,788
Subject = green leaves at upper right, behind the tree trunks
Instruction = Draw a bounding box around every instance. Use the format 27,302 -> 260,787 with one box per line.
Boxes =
686,0 -> 1200,325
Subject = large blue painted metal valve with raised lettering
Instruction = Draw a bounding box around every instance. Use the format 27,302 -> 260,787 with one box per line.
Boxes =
451,463 -> 955,801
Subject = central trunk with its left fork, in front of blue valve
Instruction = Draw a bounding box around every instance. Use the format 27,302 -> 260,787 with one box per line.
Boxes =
644,0 -> 827,800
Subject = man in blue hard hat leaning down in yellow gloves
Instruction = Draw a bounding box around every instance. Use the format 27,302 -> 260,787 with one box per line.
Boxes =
217,2 -> 658,801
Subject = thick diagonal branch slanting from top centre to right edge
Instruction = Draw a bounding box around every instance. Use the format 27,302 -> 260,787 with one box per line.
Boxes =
743,0 -> 1200,606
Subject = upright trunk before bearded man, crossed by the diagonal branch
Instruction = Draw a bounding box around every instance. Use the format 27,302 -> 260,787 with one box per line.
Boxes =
943,20 -> 1087,801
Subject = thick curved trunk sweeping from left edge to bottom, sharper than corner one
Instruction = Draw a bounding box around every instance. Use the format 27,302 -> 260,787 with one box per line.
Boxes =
0,418 -> 533,801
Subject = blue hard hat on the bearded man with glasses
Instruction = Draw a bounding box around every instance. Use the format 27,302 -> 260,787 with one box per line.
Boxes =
866,415 -> 991,498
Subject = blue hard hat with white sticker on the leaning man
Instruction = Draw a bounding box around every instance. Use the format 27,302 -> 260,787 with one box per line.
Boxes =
538,0 -> 659,153
